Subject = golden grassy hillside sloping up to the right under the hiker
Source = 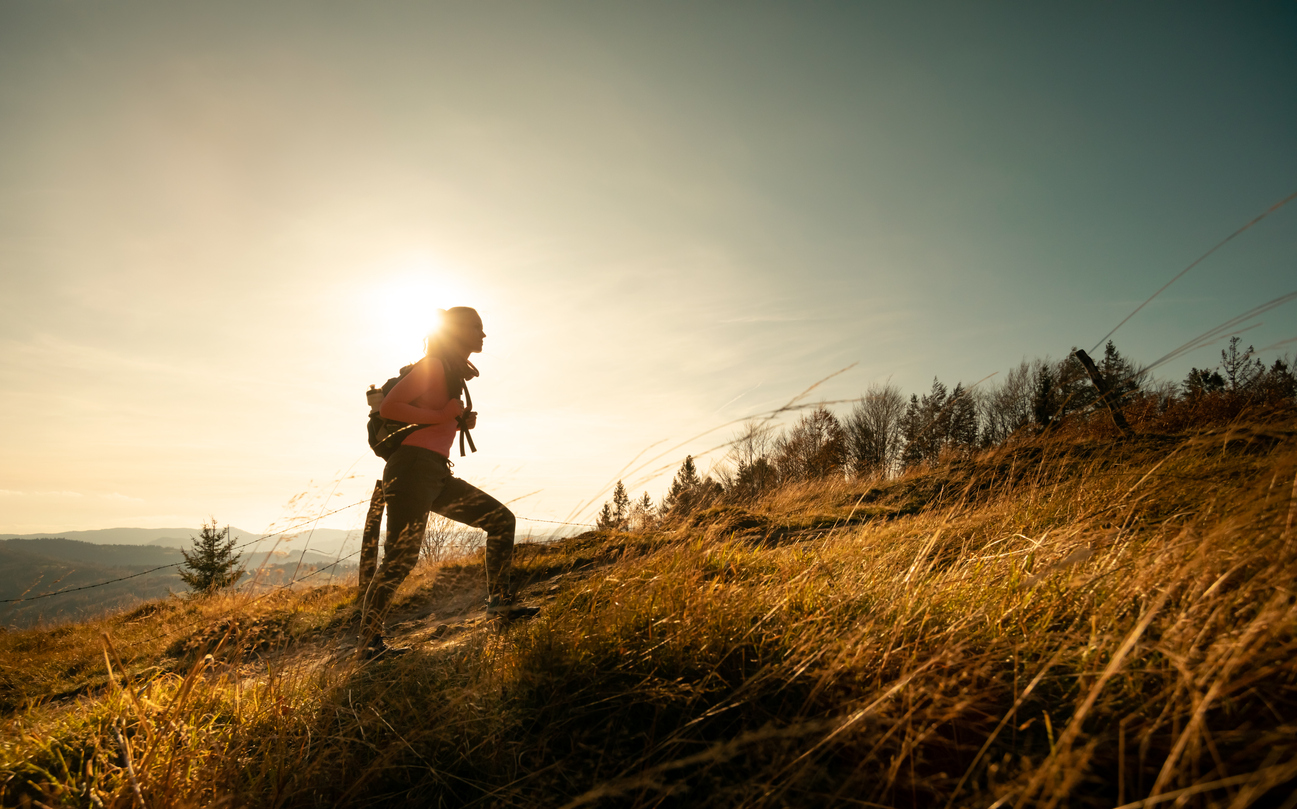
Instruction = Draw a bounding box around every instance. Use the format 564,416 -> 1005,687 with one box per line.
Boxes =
0,423 -> 1297,806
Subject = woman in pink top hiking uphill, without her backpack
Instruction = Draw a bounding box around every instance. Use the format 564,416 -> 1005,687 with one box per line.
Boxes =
361,306 -> 537,659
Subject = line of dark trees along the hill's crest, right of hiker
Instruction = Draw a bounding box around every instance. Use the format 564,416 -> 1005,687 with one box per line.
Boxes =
597,337 -> 1297,530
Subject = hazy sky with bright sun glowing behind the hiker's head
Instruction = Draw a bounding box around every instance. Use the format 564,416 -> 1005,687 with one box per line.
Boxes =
0,0 -> 1297,535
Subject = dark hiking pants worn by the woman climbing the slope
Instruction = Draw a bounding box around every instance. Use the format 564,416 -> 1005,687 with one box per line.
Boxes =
361,446 -> 516,642
